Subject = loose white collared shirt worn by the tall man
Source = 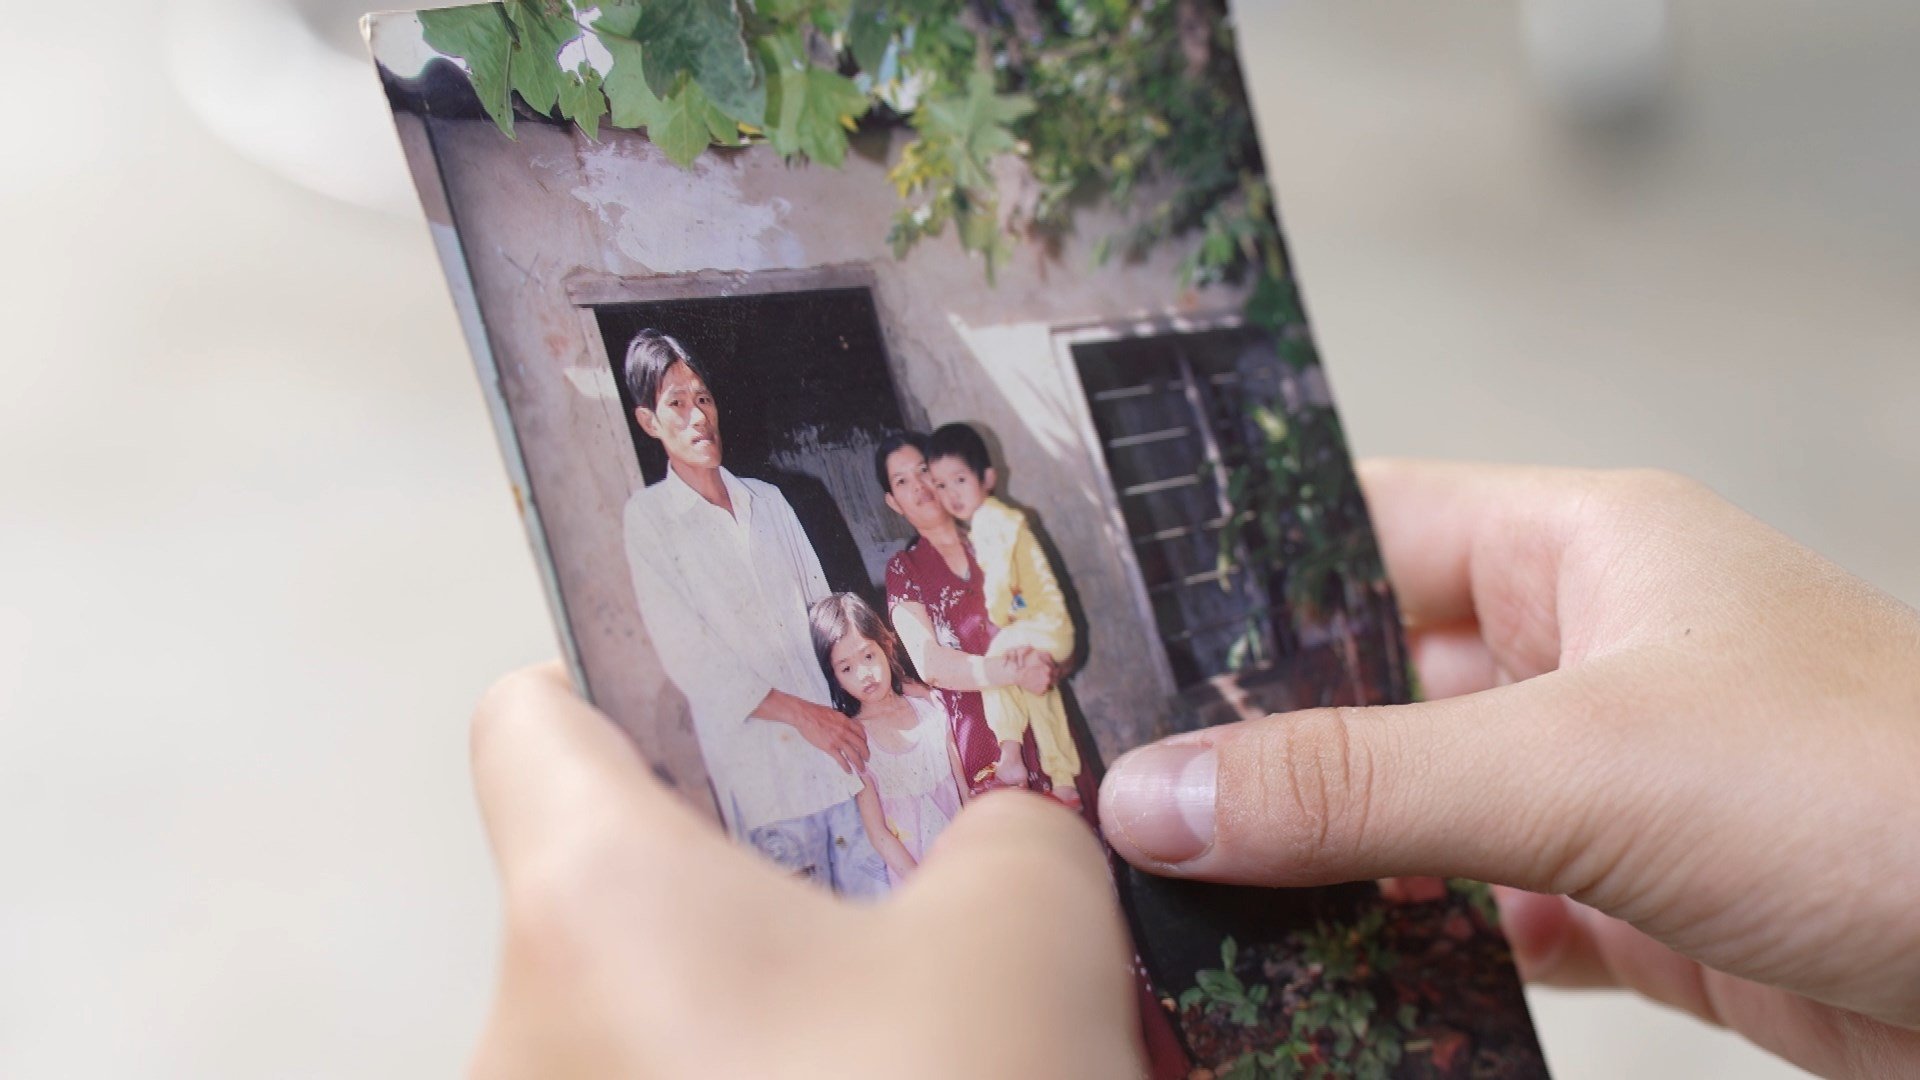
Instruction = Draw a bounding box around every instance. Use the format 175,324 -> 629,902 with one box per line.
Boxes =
626,469 -> 860,822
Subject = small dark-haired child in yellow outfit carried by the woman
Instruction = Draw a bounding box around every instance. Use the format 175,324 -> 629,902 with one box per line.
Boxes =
927,423 -> 1081,805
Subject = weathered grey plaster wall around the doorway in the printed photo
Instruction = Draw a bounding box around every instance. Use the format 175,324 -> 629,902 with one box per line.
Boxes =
428,119 -> 1242,810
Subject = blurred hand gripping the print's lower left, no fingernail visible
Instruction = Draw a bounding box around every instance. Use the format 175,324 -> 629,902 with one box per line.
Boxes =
472,667 -> 1140,1080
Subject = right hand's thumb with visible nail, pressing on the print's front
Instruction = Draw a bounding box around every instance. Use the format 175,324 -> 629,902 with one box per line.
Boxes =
1100,671 -> 1620,892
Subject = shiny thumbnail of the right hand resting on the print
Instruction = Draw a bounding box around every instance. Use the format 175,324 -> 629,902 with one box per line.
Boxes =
1100,746 -> 1219,865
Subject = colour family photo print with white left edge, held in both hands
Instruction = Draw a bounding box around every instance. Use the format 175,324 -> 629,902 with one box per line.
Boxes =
367,0 -> 1546,1078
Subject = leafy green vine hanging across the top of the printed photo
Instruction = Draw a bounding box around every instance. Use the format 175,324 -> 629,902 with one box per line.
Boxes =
420,0 -> 1300,294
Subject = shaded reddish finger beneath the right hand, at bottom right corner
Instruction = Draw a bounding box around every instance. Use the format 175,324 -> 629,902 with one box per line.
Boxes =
1496,888 -> 1920,1078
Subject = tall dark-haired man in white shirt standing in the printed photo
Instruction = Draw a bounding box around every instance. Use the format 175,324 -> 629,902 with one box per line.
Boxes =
626,331 -> 887,896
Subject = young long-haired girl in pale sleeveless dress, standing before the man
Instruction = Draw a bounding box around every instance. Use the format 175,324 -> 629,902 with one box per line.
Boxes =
812,592 -> 966,884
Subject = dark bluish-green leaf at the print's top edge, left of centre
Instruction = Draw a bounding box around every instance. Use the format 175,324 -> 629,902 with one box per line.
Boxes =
634,0 -> 766,127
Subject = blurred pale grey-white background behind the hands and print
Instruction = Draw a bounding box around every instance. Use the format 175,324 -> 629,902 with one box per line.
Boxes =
0,0 -> 1920,1080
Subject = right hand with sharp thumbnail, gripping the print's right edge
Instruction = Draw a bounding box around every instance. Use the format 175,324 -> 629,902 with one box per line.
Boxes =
1100,463 -> 1920,1076
